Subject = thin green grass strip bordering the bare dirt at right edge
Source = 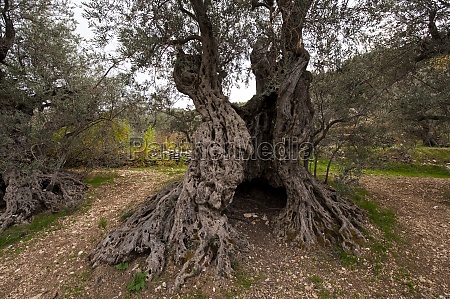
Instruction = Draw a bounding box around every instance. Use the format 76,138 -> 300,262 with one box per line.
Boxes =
364,163 -> 450,178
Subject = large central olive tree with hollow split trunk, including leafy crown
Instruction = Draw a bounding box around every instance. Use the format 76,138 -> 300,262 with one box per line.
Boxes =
87,0 -> 364,287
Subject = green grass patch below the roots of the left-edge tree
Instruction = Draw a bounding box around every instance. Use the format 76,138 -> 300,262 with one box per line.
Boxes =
0,212 -> 68,249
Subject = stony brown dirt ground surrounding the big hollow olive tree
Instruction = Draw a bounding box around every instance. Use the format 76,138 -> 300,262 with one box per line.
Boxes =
0,170 -> 450,299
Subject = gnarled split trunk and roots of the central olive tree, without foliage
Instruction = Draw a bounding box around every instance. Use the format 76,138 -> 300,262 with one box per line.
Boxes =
90,0 -> 364,289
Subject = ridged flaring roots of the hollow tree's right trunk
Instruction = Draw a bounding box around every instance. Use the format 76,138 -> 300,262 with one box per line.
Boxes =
274,167 -> 365,254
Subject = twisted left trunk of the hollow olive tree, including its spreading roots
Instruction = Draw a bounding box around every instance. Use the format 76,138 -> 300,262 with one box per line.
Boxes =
91,1 -> 252,289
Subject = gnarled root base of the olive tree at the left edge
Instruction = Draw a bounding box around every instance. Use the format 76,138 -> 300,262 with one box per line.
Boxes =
0,169 -> 87,232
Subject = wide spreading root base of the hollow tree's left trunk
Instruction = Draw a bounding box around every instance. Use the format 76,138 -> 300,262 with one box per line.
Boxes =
90,177 -> 246,291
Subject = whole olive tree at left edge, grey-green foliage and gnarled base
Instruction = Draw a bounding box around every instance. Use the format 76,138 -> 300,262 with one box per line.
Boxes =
0,1 -> 137,231
